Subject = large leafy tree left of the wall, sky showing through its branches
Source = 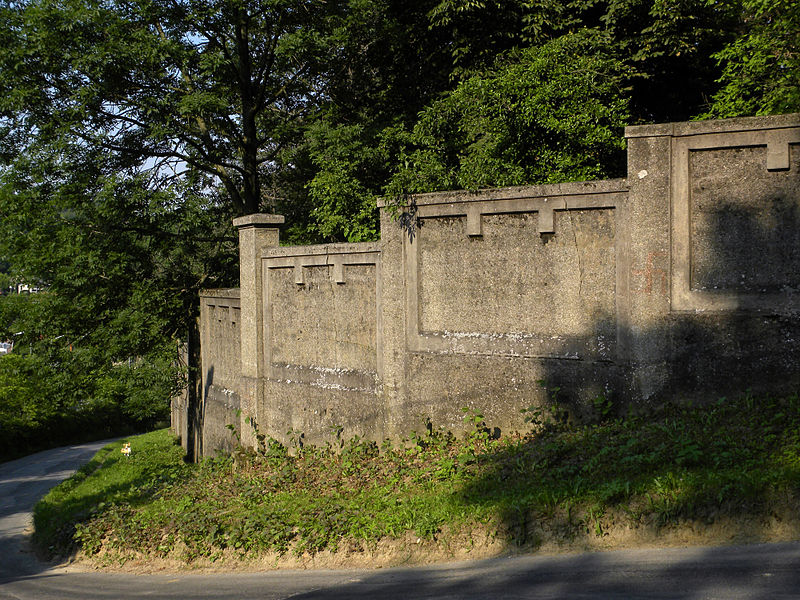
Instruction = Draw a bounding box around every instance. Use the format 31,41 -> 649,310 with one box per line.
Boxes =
0,0 -> 343,442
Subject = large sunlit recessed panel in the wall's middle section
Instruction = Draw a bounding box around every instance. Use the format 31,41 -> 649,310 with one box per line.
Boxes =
417,209 -> 616,358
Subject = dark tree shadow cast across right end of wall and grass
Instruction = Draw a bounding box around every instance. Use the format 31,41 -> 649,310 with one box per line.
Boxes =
444,186 -> 800,548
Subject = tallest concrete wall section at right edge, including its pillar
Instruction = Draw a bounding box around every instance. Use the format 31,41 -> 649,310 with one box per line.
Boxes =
627,115 -> 800,402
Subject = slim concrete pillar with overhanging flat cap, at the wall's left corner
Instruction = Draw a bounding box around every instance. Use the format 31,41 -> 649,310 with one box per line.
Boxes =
233,214 -> 284,447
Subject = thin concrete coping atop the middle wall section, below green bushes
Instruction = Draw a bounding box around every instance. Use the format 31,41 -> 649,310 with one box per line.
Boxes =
378,179 -> 628,208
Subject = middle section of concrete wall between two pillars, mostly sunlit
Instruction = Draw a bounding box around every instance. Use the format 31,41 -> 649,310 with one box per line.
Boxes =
383,180 -> 627,434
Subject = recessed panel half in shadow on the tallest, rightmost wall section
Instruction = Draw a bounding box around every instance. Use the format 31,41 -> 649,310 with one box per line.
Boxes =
689,144 -> 800,294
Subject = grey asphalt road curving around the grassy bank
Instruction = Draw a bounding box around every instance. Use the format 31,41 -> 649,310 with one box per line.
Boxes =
0,442 -> 800,600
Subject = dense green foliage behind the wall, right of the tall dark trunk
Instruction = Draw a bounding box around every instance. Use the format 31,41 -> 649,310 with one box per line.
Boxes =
304,0 -> 800,227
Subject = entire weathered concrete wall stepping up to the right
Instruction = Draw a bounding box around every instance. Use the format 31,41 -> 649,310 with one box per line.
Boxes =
184,115 -> 800,460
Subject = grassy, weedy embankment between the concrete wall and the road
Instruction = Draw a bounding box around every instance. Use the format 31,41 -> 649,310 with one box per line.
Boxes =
35,396 -> 800,562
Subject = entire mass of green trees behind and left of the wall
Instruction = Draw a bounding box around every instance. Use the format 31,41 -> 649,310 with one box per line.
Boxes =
0,0 -> 800,459
